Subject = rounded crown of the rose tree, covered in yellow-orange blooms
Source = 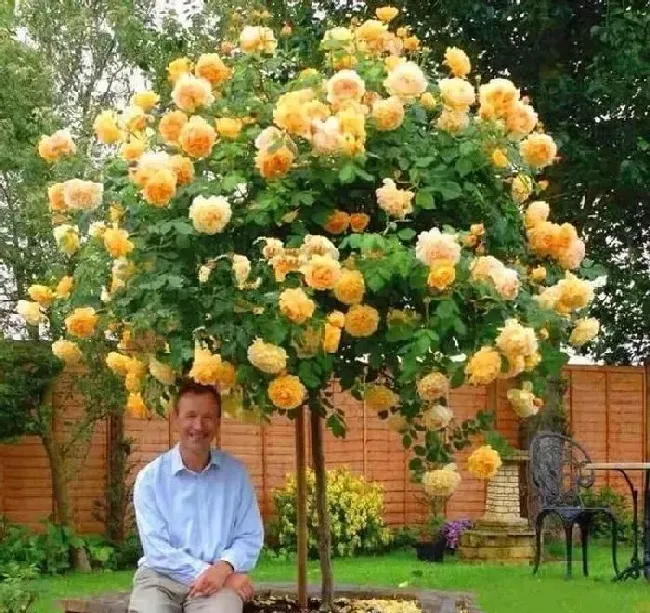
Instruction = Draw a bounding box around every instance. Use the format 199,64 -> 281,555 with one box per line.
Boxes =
26,7 -> 598,608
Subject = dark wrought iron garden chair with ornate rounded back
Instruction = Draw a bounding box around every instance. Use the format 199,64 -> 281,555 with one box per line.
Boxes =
529,432 -> 618,577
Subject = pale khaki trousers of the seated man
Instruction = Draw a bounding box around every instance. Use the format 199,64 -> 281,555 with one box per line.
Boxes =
129,566 -> 244,613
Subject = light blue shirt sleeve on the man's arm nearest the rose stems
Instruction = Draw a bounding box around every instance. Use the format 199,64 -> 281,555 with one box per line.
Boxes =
219,470 -> 264,573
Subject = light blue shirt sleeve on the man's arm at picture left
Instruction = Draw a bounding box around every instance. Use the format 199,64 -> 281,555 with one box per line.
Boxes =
133,473 -> 210,579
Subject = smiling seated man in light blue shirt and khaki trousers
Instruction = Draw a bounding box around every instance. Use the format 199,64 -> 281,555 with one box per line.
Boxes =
129,382 -> 264,613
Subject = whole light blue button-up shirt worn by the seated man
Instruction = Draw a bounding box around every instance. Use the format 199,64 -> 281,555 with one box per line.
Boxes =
133,445 -> 264,585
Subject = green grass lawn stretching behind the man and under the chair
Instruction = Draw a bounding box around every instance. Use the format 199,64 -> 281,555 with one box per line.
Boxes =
33,546 -> 650,613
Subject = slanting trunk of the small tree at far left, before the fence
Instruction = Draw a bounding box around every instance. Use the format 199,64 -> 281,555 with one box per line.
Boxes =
39,385 -> 91,572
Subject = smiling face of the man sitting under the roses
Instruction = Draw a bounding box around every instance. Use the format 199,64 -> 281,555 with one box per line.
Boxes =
177,393 -> 219,453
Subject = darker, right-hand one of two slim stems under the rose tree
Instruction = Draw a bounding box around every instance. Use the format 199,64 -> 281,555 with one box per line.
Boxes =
311,407 -> 334,611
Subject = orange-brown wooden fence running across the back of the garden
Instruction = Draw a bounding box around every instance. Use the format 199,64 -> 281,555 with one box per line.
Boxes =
0,366 -> 650,532
